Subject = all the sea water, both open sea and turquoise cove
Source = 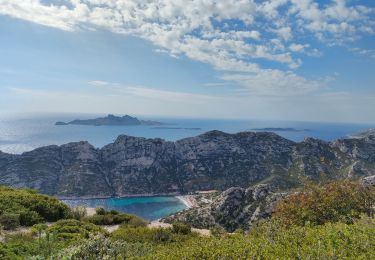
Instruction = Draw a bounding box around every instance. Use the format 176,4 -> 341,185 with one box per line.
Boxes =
0,114 -> 375,220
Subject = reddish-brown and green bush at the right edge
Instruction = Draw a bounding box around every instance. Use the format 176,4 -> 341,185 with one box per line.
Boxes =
273,181 -> 375,226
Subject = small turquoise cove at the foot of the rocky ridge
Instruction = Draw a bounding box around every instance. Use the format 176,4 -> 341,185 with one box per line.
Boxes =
63,196 -> 186,220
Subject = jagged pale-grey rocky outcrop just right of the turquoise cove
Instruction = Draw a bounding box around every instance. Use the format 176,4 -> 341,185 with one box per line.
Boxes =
164,184 -> 286,232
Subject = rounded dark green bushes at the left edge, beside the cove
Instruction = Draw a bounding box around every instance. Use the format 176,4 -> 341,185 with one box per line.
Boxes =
0,186 -> 70,229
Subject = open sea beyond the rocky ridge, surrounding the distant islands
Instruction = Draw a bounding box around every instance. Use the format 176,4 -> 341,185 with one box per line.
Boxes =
0,114 -> 375,154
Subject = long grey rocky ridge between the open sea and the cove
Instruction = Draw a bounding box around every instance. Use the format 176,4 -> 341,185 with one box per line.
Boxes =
0,131 -> 375,197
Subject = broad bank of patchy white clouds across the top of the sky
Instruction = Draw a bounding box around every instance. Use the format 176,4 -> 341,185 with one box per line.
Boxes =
0,0 -> 374,95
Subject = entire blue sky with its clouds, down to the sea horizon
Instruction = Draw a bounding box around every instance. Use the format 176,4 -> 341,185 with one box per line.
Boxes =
0,0 -> 375,123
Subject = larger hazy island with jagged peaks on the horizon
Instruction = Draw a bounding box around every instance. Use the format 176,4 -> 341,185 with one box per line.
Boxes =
55,115 -> 163,126
